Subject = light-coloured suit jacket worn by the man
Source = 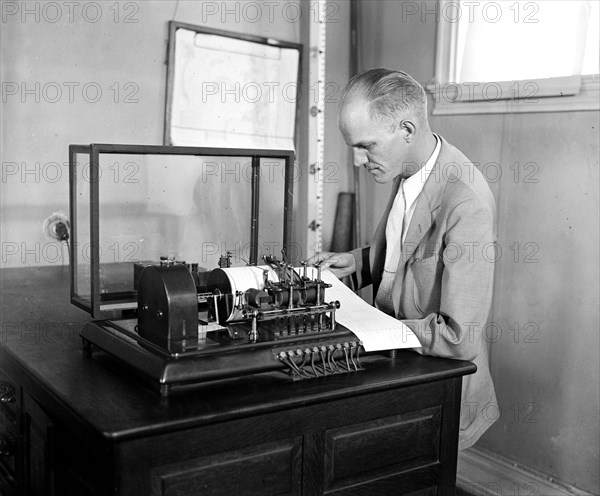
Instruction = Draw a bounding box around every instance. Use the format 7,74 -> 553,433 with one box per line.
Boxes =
352,138 -> 499,449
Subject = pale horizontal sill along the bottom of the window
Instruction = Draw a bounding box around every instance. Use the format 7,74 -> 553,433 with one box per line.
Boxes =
426,74 -> 600,115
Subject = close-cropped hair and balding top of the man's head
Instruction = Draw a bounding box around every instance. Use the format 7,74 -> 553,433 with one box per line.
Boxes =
340,69 -> 429,129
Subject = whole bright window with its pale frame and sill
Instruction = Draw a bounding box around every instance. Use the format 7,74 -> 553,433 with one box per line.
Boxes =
428,0 -> 600,114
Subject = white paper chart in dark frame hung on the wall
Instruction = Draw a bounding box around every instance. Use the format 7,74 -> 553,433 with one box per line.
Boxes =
170,28 -> 299,150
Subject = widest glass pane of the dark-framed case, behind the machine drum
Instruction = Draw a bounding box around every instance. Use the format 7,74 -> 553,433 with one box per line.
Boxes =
99,153 -> 255,310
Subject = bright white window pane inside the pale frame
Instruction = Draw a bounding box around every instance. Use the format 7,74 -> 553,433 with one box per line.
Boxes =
458,0 -> 598,82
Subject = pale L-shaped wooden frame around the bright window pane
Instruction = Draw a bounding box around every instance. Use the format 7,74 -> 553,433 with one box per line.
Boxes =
425,0 -> 600,115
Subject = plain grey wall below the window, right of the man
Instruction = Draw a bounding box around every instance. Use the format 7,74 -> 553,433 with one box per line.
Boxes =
474,112 -> 599,493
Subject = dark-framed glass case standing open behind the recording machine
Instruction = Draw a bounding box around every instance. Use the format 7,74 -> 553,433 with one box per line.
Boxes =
69,144 -> 294,319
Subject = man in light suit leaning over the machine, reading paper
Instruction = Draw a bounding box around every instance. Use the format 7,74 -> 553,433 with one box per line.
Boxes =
312,69 -> 498,449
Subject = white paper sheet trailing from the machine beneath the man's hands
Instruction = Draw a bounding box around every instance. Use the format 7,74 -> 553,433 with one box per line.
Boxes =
321,270 -> 421,351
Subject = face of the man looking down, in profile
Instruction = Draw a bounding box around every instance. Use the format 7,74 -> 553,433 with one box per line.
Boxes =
338,98 -> 414,183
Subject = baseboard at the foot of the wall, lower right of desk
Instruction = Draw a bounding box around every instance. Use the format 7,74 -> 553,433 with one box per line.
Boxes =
456,448 -> 594,496
